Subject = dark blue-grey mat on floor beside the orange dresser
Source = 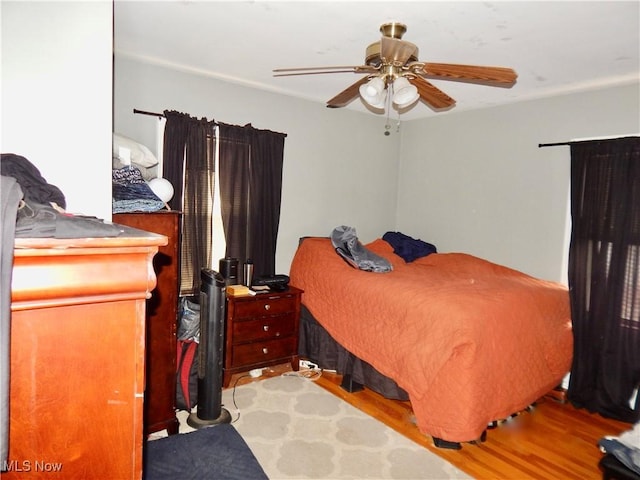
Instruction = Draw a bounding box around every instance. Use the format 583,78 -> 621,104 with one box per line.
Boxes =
143,423 -> 268,480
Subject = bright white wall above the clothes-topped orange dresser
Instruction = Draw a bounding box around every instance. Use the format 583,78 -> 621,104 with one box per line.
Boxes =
0,1 -> 113,220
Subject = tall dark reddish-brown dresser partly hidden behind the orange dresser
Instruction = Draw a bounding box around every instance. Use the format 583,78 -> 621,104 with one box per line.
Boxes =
113,210 -> 182,435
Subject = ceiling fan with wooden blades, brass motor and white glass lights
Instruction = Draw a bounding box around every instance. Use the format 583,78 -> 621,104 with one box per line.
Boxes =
273,23 -> 517,111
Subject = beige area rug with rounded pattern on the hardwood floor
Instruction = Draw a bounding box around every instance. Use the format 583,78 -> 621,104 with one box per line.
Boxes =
179,375 -> 471,480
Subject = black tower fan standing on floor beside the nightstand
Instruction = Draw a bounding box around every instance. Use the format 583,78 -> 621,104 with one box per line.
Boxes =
187,268 -> 231,428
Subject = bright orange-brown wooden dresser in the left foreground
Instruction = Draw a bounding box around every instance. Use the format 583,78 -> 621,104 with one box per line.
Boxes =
2,229 -> 167,480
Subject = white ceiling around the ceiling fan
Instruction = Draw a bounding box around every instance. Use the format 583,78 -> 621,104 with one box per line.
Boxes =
114,0 -> 640,120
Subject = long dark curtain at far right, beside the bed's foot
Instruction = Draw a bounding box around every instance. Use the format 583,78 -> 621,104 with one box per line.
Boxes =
567,137 -> 640,422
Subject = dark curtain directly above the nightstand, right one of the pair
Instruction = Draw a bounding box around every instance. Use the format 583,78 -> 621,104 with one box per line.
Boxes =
219,124 -> 286,277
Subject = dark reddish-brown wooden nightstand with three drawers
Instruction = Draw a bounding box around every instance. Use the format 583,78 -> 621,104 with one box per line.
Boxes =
223,287 -> 303,387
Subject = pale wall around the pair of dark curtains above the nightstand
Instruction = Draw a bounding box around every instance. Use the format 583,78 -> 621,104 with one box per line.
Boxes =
114,55 -> 399,273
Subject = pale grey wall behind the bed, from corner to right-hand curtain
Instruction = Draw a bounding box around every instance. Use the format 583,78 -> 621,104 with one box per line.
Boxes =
397,84 -> 640,281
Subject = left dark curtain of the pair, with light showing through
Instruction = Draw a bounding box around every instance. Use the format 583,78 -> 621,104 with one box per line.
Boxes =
163,111 -> 215,295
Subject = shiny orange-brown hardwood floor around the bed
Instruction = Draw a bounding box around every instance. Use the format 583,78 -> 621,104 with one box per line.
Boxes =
230,364 -> 631,480
